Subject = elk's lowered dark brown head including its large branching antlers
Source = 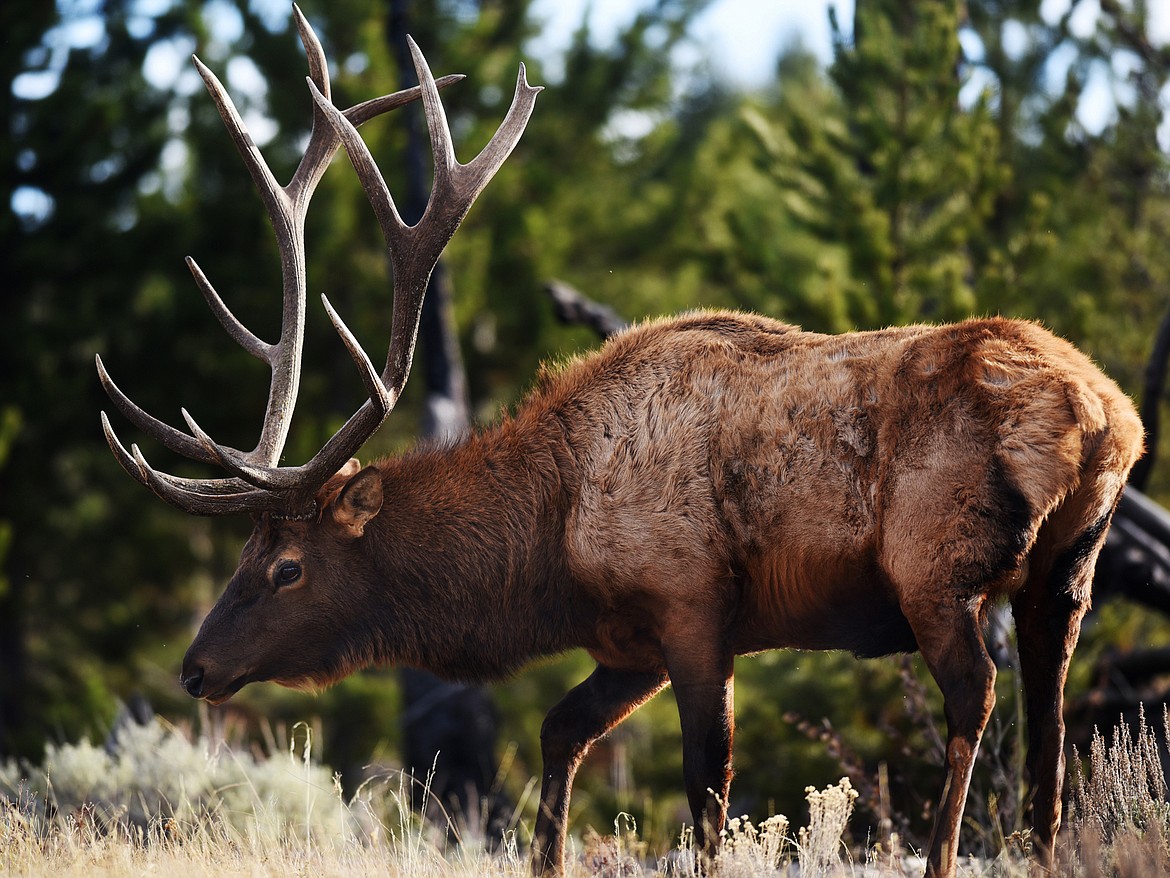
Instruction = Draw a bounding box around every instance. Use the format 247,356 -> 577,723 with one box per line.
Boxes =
96,6 -> 541,702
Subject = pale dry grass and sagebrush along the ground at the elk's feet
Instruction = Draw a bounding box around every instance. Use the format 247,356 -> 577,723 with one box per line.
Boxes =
0,713 -> 1170,878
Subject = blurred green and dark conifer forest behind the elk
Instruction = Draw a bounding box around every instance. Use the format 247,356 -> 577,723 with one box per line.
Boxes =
0,0 -> 1170,856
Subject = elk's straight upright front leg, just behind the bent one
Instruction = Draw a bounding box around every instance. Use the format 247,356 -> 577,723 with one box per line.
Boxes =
667,629 -> 735,864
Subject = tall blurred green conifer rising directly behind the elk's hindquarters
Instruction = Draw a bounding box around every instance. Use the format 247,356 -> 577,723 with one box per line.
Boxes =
813,0 -> 1006,325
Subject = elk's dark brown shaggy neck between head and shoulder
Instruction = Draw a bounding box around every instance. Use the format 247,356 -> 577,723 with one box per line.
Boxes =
353,420 -> 591,680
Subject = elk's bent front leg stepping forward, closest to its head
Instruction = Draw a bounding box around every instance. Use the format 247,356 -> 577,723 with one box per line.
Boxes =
532,665 -> 667,876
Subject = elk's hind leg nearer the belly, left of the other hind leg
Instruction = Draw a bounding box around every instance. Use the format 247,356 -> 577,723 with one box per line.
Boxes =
903,588 -> 996,878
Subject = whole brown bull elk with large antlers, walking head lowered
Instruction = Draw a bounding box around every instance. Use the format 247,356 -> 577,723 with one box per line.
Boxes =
97,12 -> 1142,876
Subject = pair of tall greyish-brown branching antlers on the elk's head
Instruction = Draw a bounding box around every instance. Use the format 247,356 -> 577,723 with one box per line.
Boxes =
96,6 -> 541,516
